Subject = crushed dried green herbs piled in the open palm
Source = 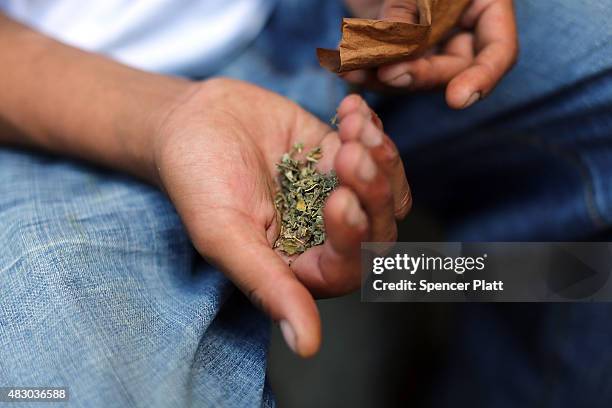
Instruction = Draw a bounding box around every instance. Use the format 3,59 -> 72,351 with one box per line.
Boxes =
274,143 -> 338,255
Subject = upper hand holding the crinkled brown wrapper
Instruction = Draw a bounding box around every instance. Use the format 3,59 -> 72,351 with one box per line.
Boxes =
343,0 -> 518,109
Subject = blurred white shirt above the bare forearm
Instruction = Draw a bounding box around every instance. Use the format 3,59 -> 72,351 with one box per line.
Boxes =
0,0 -> 275,76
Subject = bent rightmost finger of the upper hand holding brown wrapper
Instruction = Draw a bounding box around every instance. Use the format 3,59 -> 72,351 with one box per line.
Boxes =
446,0 -> 518,109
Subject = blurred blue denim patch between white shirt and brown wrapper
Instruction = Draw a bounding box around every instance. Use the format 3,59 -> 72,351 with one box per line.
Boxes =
216,0 -> 348,121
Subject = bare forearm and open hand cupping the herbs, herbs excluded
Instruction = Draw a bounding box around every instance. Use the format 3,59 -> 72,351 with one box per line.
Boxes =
0,15 -> 411,356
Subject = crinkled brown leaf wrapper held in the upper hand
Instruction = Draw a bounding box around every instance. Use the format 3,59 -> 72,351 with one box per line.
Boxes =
317,0 -> 471,73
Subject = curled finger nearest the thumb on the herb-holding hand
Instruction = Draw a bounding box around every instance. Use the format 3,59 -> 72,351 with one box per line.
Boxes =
292,186 -> 368,297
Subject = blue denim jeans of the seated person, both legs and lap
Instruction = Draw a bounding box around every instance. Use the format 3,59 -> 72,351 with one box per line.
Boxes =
0,0 -> 612,407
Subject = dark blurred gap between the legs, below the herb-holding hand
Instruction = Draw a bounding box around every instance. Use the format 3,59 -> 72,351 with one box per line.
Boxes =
268,208 -> 456,408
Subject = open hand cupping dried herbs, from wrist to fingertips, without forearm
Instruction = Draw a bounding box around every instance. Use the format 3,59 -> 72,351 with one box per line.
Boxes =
154,79 -> 411,356
